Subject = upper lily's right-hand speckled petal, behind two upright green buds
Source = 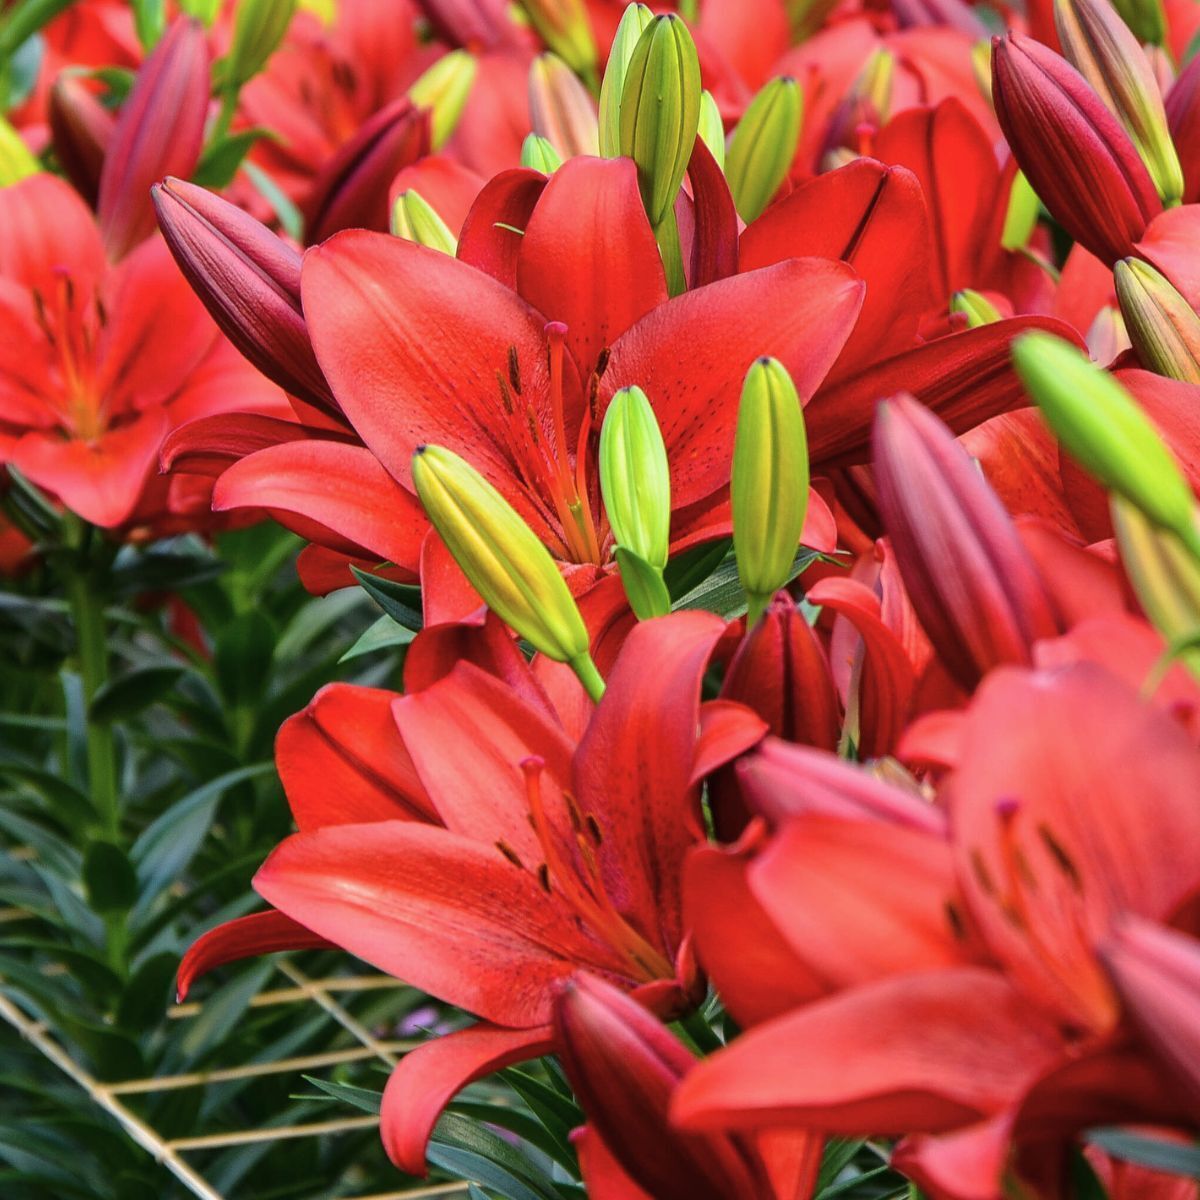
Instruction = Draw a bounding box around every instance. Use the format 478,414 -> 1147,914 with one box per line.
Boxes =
604,258 -> 863,508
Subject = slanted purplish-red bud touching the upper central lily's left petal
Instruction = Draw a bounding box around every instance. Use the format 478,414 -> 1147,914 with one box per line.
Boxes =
154,179 -> 337,412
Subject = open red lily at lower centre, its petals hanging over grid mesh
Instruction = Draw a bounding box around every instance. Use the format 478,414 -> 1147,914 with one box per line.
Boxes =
180,613 -> 763,1172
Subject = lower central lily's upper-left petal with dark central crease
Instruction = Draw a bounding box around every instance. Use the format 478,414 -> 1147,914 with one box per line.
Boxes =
275,683 -> 438,832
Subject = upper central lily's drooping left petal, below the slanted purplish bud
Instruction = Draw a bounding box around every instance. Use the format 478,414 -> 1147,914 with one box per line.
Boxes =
212,439 -> 428,570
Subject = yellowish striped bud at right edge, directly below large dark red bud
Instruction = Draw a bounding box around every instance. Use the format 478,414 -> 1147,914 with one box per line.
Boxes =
1112,258 -> 1200,384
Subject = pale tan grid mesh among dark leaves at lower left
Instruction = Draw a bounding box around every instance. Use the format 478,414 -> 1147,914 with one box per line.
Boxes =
0,955 -> 468,1200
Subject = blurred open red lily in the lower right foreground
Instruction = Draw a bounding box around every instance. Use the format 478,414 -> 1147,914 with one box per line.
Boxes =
674,662 -> 1200,1200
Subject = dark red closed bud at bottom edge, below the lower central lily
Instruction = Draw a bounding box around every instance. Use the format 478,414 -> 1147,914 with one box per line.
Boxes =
554,974 -> 772,1200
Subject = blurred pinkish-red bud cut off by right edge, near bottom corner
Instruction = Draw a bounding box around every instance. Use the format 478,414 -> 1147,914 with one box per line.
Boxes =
1100,917 -> 1200,1104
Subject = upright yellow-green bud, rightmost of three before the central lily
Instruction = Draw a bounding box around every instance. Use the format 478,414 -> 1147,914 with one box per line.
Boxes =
730,358 -> 809,625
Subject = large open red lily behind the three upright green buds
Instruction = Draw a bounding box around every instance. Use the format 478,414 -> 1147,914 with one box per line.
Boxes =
187,157 -> 862,604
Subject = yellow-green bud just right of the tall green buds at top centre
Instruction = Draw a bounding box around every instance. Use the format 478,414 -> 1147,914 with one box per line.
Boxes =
725,76 -> 804,222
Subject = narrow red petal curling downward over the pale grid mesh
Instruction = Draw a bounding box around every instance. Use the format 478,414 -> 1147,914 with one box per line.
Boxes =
379,1024 -> 553,1175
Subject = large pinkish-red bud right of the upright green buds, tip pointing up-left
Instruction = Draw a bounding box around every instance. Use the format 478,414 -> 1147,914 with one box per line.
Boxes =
875,397 -> 1060,689
